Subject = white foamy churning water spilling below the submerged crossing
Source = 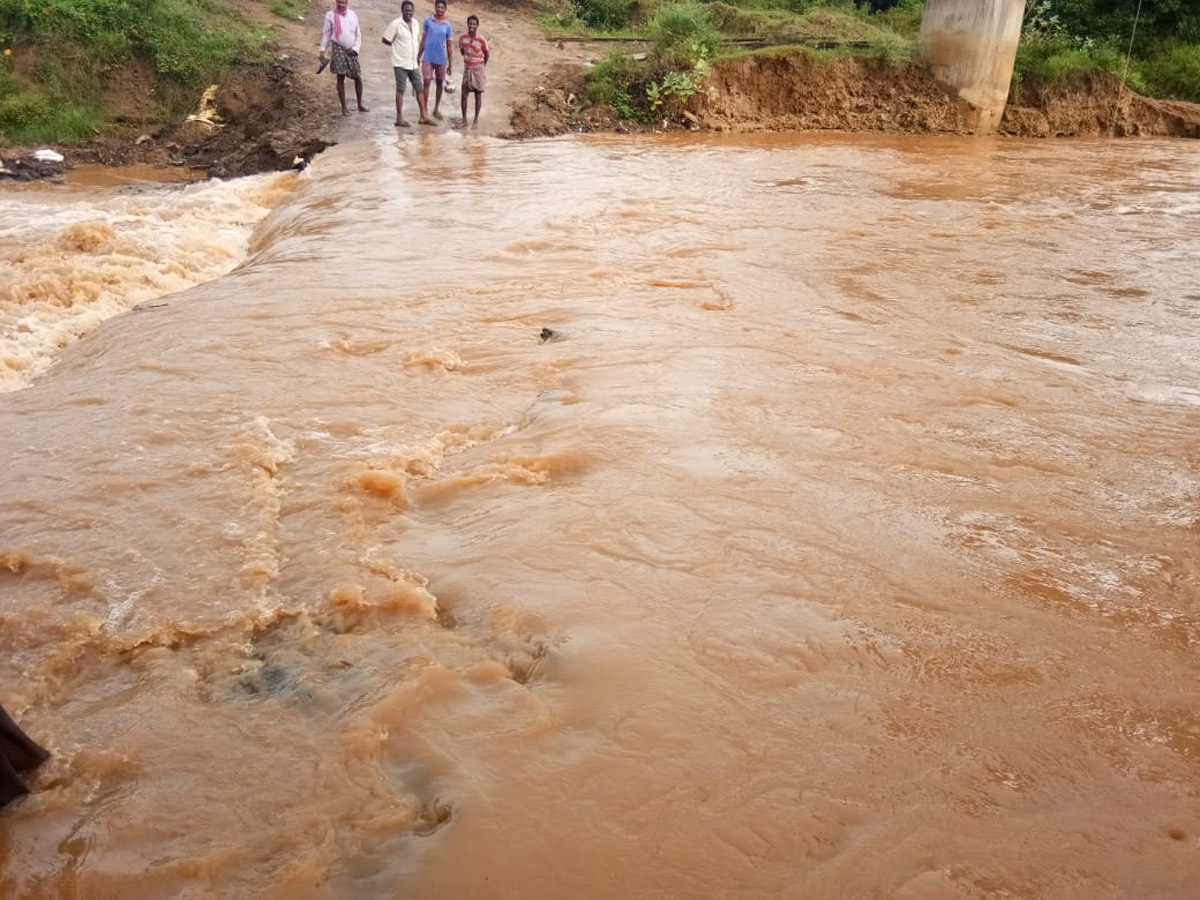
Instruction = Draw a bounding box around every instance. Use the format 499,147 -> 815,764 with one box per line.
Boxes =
0,174 -> 296,391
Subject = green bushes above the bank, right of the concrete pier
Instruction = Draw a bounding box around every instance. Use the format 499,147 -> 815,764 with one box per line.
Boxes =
1013,0 -> 1200,102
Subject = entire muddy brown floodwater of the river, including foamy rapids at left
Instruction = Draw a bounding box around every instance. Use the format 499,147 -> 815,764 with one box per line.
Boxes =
0,134 -> 1200,899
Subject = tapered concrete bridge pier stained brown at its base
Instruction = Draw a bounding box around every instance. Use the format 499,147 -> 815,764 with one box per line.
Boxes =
920,0 -> 1025,134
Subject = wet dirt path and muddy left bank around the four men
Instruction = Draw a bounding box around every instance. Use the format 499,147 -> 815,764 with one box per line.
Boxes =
4,0 -> 585,178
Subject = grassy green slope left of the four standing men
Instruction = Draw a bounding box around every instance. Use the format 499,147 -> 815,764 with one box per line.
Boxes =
0,0 -> 270,144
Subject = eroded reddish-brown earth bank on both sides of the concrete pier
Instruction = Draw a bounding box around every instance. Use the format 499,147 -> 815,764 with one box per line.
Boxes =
512,50 -> 1200,137
